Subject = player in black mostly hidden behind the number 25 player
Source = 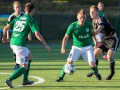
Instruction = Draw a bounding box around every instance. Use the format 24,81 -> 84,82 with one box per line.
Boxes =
7,1 -> 32,70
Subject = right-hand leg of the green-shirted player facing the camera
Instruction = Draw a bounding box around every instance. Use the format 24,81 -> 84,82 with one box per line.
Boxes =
82,46 -> 101,80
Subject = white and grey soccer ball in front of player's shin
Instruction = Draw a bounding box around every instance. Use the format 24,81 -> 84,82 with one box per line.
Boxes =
64,64 -> 76,75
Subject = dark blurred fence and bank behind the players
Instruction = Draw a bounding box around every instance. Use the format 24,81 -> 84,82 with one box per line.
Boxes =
0,0 -> 120,42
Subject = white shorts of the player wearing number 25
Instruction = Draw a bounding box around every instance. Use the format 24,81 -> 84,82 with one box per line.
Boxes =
10,45 -> 30,64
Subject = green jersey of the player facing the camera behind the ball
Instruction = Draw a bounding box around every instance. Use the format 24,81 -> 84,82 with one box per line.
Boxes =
66,21 -> 93,47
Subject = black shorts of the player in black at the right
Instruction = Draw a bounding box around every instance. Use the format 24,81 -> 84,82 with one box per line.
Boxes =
97,37 -> 119,52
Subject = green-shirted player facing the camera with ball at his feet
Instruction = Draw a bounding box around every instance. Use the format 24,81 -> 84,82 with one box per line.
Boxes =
56,9 -> 101,82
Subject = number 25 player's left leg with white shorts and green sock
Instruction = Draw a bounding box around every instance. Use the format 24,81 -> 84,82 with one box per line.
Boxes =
5,46 -> 28,88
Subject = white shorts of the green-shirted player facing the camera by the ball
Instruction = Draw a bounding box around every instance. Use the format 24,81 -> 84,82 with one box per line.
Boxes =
67,46 -> 95,63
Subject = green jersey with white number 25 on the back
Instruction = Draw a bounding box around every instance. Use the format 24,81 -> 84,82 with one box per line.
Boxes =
10,14 -> 39,47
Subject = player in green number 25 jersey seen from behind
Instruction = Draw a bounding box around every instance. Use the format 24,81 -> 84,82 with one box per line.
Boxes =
2,3 -> 50,88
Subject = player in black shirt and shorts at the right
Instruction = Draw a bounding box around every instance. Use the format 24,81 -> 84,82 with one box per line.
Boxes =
88,5 -> 119,80
